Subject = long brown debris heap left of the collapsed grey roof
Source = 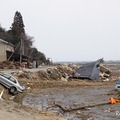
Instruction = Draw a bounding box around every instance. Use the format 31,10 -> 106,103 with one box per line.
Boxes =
13,65 -> 76,81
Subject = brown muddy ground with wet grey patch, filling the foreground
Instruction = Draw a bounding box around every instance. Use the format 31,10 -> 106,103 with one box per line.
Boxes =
0,63 -> 120,120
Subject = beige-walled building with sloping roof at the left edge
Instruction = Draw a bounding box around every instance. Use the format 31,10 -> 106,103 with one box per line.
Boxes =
0,39 -> 14,62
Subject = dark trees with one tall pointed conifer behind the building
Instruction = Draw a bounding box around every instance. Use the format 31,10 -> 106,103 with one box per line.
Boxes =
0,11 -> 50,64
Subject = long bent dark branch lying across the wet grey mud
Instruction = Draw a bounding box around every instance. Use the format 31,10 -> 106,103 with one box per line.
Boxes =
54,102 -> 110,112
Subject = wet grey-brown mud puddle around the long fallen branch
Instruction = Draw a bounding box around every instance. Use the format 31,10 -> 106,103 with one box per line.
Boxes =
23,86 -> 120,120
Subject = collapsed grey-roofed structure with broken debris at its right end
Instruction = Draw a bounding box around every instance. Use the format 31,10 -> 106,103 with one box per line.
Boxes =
71,59 -> 111,80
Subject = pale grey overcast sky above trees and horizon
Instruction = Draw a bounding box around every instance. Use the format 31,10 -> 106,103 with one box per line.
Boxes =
0,0 -> 120,62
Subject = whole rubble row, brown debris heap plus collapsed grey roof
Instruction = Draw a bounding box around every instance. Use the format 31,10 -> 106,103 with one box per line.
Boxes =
11,59 -> 111,82
